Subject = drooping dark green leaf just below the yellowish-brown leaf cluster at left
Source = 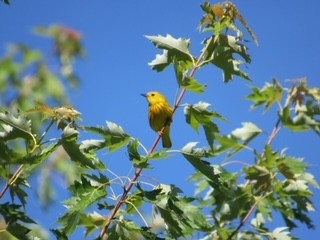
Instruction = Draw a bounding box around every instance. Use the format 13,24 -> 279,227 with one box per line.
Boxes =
61,126 -> 105,170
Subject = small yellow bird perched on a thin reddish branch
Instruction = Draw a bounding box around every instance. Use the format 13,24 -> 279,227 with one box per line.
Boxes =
141,92 -> 172,148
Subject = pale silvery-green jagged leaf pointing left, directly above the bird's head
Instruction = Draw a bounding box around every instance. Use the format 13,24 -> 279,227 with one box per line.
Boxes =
146,34 -> 193,72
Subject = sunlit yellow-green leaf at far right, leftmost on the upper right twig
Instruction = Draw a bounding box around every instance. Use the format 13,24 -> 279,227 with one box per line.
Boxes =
247,79 -> 283,111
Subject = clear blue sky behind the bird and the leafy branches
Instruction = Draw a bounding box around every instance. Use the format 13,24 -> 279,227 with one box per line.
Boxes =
0,0 -> 320,239
